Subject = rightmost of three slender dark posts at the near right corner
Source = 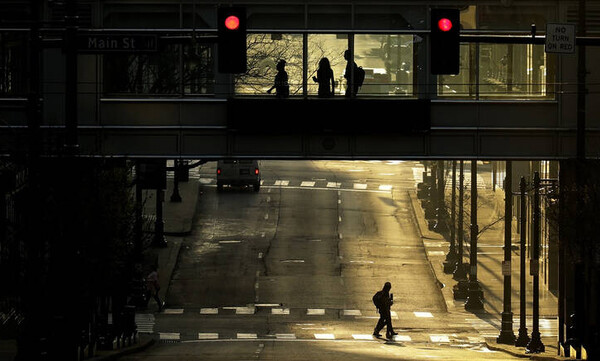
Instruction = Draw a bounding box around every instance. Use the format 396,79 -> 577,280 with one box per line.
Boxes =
527,172 -> 546,353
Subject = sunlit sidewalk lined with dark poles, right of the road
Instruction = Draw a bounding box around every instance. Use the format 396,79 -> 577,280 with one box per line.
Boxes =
409,189 -> 567,360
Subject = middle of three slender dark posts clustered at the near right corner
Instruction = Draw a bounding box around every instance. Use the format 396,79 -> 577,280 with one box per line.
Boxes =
515,177 -> 529,347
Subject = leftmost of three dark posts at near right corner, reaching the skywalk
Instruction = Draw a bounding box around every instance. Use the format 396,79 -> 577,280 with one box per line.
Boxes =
496,160 -> 515,345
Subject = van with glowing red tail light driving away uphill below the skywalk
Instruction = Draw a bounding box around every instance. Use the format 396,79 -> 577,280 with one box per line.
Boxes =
217,159 -> 260,192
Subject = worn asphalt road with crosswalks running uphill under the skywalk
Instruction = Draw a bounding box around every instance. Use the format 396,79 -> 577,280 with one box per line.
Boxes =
123,161 -> 512,361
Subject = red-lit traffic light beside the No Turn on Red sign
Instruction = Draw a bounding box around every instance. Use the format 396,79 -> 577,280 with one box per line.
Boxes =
429,9 -> 460,74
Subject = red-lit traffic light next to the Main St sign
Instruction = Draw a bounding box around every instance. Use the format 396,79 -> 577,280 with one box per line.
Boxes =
217,7 -> 246,73
